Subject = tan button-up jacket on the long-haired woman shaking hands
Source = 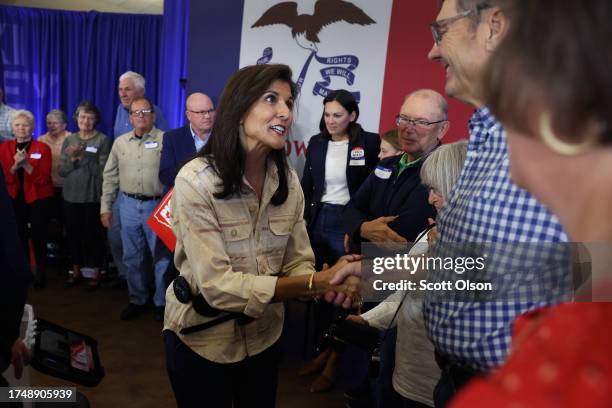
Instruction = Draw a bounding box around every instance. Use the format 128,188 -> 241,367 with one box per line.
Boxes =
164,158 -> 314,363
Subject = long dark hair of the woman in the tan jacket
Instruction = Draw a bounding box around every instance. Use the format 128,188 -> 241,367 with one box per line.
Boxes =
197,64 -> 295,205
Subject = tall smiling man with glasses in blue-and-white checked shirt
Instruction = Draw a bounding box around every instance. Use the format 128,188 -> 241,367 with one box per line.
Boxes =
423,0 -> 567,407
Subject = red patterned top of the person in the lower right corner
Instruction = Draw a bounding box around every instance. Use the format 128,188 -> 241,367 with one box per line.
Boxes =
451,302 -> 612,408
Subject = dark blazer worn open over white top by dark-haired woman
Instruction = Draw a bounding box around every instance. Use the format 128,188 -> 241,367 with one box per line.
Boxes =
302,131 -> 380,230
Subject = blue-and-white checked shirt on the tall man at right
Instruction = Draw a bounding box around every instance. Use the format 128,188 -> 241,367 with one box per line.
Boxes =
423,107 -> 569,371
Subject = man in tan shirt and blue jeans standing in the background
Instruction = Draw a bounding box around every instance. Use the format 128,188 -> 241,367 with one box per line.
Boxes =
100,98 -> 170,321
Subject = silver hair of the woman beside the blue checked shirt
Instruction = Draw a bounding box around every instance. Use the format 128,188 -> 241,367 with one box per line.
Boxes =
421,140 -> 467,199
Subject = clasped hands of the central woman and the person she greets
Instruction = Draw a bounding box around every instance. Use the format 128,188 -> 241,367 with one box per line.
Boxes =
315,255 -> 363,309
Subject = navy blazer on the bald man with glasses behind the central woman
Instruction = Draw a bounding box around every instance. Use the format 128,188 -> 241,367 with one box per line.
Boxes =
159,124 -> 197,189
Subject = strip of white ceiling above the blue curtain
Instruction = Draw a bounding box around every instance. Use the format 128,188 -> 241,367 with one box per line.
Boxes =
0,0 -> 164,14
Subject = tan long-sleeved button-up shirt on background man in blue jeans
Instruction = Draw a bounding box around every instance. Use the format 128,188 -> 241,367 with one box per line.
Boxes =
100,127 -> 164,214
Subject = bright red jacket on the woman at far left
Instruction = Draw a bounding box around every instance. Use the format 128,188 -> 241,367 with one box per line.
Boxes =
0,140 -> 53,204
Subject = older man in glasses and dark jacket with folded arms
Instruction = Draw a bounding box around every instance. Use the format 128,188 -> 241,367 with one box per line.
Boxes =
344,89 -> 450,251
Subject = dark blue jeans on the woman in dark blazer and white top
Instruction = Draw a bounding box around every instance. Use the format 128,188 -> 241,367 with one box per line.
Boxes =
309,203 -> 344,271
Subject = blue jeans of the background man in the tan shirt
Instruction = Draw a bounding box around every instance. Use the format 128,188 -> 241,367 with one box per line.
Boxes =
117,193 -> 170,306
